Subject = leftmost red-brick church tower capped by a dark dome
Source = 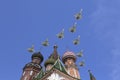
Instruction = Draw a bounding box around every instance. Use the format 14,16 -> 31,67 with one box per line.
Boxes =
20,52 -> 43,80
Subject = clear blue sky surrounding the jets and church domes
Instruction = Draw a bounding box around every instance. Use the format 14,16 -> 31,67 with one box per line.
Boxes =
0,0 -> 120,80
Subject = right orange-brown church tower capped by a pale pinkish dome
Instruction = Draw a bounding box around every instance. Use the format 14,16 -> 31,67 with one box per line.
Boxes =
62,51 -> 80,79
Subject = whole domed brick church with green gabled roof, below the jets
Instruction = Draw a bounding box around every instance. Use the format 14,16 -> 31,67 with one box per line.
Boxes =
20,45 -> 81,80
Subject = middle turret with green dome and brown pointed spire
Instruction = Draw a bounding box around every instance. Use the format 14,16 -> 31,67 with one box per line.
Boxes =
44,45 -> 59,71
